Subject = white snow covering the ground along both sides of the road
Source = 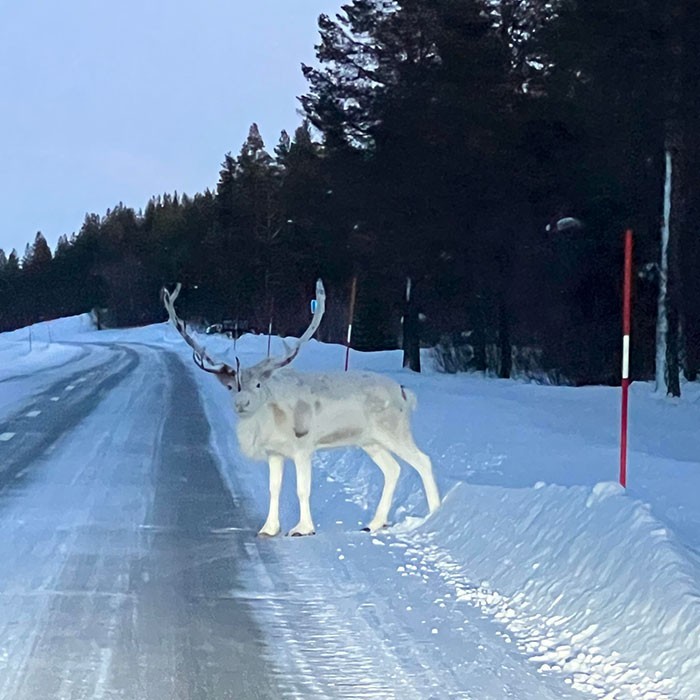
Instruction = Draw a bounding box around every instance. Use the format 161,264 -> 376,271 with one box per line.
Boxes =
0,317 -> 700,700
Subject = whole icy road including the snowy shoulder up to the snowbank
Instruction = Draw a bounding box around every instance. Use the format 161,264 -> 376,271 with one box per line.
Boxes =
0,344 -> 588,700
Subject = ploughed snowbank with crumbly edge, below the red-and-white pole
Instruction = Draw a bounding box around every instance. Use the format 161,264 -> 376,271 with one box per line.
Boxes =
398,483 -> 700,700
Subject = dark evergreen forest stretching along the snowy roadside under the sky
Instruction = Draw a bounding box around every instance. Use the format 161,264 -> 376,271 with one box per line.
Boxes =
0,0 -> 700,393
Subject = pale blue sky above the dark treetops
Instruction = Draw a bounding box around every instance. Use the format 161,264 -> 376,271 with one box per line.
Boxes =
0,0 -> 342,255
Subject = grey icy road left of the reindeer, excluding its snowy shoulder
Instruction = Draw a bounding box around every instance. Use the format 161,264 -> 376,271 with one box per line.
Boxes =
0,346 -> 276,700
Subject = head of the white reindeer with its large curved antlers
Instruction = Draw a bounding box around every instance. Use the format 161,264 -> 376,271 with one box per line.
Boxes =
161,279 -> 326,415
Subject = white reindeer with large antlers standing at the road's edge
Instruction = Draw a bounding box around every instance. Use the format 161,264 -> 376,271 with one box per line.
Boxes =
163,280 -> 440,537
